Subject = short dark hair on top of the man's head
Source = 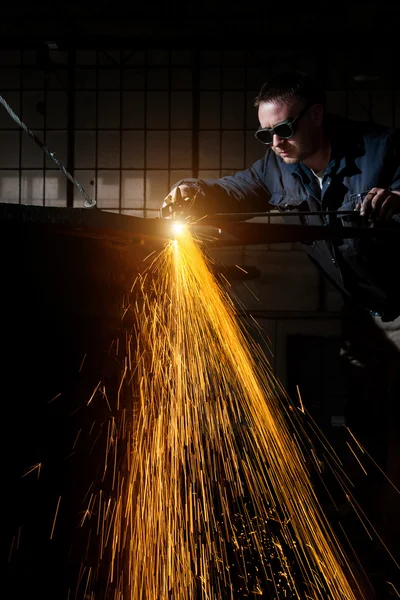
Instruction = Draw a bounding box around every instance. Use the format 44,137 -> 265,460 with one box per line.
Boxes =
254,71 -> 323,107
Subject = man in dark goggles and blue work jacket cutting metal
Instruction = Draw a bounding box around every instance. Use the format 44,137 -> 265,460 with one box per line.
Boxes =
164,73 -> 400,321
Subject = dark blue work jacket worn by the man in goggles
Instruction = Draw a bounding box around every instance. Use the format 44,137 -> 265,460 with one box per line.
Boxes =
175,116 -> 400,321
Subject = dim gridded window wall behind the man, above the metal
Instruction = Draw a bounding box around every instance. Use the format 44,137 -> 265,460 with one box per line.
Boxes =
0,46 -> 400,229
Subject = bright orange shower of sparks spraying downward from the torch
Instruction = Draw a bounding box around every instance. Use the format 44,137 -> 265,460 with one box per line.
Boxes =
78,232 -> 367,600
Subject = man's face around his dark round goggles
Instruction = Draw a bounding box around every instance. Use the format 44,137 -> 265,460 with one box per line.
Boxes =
258,99 -> 322,165
